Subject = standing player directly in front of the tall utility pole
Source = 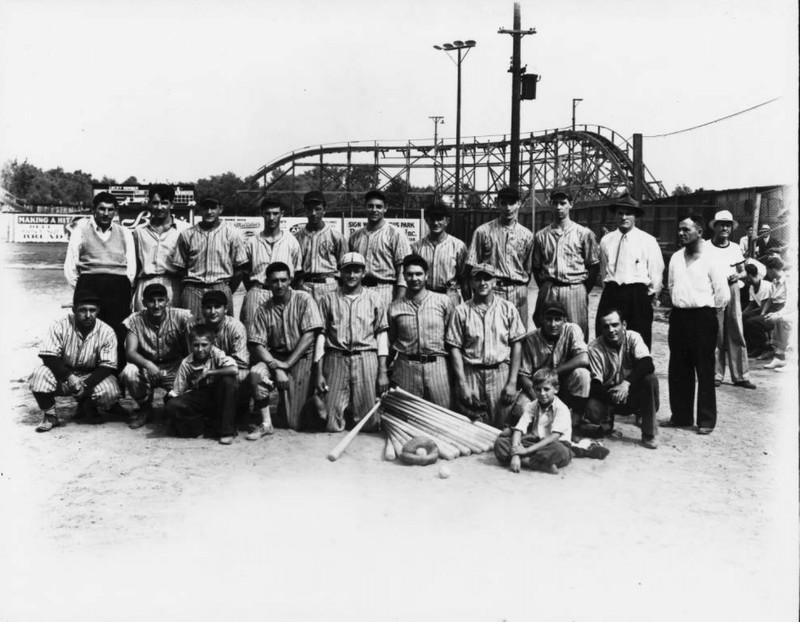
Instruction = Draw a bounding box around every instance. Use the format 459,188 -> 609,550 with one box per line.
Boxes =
467,188 -> 533,325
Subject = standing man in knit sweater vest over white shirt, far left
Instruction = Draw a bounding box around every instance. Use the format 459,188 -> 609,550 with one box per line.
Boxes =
64,192 -> 136,369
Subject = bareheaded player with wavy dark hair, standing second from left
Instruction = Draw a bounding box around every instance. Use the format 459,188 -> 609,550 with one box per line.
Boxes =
133,184 -> 191,311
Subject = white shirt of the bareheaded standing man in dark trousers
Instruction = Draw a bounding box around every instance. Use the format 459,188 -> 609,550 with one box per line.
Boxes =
669,241 -> 731,309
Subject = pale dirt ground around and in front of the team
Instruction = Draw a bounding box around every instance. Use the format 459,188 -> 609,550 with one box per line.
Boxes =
0,244 -> 798,622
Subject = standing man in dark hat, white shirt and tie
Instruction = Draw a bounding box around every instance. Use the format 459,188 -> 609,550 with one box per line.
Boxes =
594,195 -> 664,350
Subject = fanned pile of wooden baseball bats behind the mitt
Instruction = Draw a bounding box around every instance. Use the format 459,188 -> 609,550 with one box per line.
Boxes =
381,388 -> 500,460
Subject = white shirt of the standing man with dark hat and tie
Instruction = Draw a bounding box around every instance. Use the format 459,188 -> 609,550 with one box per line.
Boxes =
600,227 -> 664,296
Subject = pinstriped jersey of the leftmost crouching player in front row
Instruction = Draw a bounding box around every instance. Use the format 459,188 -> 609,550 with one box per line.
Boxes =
39,313 -> 117,372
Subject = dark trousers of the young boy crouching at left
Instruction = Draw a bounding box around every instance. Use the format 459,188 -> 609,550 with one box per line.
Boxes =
166,376 -> 239,438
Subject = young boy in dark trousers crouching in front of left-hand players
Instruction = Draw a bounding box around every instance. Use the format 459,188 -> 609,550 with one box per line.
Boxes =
165,325 -> 238,445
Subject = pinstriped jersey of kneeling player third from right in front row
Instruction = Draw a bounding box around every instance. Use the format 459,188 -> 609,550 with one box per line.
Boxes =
445,296 -> 525,365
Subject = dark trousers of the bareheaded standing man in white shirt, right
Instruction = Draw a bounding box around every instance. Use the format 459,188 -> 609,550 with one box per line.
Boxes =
668,307 -> 719,428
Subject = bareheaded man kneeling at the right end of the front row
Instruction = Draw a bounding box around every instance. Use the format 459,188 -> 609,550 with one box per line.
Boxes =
585,309 -> 659,449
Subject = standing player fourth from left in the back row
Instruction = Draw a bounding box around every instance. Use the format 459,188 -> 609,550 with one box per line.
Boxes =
239,197 -> 302,330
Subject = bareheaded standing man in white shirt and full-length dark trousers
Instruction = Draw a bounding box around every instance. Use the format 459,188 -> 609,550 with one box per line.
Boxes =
661,215 -> 731,434
